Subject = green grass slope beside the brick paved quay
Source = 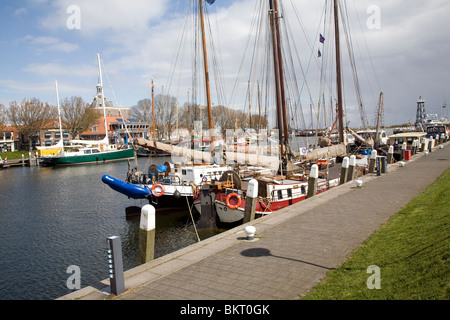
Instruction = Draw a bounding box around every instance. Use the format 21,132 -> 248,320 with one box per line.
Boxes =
302,169 -> 450,300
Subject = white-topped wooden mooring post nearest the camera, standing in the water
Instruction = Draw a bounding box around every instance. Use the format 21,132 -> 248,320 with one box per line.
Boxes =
138,204 -> 156,264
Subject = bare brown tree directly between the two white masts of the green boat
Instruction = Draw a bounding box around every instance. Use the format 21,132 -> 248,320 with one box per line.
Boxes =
61,97 -> 102,139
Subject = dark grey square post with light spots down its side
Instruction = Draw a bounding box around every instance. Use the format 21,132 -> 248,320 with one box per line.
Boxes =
106,236 -> 125,296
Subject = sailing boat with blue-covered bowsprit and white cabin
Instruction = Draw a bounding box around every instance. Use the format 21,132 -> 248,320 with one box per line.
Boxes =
102,0 -> 232,206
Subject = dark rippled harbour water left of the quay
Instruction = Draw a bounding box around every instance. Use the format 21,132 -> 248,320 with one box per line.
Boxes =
0,158 -> 215,300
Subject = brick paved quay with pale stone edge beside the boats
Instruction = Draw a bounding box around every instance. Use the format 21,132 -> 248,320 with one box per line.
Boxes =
60,143 -> 450,300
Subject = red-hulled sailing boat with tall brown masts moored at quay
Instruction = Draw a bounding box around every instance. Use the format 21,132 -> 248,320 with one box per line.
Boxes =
209,0 -> 345,223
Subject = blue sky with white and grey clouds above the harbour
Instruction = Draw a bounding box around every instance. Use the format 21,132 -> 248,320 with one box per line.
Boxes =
0,0 -> 450,126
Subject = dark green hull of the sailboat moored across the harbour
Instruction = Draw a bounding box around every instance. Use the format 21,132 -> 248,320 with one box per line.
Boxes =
46,148 -> 134,167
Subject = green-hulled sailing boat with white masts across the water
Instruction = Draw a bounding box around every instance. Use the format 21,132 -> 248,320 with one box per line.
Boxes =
45,53 -> 134,167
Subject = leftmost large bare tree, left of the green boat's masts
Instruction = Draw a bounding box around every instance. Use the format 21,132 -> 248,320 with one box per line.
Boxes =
6,98 -> 57,150
